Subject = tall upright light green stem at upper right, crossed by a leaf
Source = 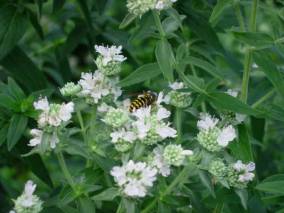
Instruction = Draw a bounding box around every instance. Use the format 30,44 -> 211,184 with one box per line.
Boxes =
241,0 -> 258,103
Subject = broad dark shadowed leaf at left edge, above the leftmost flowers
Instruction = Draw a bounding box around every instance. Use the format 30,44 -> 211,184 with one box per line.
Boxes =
0,47 -> 47,92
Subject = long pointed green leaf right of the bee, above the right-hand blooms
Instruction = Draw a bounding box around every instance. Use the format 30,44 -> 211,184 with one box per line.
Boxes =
208,92 -> 258,115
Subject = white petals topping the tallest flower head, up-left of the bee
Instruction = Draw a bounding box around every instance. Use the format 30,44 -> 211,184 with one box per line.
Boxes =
95,45 -> 126,66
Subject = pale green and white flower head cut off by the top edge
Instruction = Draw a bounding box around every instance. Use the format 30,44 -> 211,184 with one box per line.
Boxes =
126,0 -> 177,16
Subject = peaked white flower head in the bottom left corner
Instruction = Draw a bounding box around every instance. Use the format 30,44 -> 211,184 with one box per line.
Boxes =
10,180 -> 43,213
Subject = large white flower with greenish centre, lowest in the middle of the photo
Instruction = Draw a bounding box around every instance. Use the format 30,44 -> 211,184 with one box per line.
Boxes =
110,160 -> 157,197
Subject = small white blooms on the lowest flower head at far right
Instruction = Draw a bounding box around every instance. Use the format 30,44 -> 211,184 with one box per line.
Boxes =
233,160 -> 255,182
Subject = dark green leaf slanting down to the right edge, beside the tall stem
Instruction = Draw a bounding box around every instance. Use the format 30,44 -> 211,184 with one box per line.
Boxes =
253,51 -> 284,97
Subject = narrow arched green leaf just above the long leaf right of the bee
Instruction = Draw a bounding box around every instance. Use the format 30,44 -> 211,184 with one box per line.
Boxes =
184,56 -> 223,80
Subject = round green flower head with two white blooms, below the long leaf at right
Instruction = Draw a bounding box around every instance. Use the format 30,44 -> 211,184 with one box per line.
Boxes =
197,114 -> 236,152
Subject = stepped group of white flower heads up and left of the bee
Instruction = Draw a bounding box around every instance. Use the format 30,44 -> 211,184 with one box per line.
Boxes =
60,45 -> 123,104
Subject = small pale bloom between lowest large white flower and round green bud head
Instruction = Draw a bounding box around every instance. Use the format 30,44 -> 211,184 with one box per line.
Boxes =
151,146 -> 171,177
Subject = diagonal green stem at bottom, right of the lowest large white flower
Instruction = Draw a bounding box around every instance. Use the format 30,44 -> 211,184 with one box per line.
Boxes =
141,165 -> 190,213
